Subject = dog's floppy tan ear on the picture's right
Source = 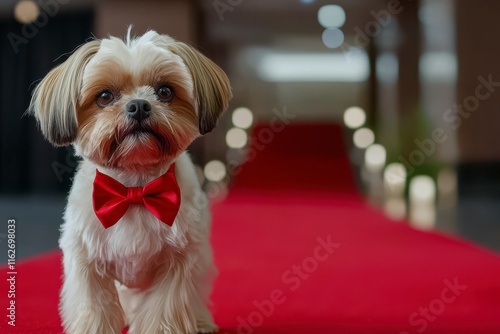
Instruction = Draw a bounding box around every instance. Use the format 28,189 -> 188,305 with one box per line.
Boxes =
168,42 -> 232,135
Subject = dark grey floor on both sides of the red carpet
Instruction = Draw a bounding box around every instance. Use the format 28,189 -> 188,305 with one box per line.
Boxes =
0,190 -> 500,263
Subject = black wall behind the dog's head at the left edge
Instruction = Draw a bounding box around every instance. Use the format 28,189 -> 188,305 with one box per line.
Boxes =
0,12 -> 94,194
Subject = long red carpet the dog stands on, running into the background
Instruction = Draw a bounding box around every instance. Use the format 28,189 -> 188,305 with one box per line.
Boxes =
0,125 -> 500,334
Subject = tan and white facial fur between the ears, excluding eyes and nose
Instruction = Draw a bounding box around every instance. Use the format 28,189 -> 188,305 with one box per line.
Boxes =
75,32 -> 199,170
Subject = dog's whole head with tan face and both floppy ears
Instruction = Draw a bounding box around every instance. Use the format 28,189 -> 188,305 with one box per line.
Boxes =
31,31 -> 231,169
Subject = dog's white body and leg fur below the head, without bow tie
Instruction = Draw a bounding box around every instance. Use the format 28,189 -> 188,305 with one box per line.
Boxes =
60,153 -> 216,334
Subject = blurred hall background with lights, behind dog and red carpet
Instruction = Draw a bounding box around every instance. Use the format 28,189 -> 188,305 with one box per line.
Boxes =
0,0 -> 500,262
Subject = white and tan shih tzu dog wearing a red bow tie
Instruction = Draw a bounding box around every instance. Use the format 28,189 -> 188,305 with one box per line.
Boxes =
30,29 -> 231,334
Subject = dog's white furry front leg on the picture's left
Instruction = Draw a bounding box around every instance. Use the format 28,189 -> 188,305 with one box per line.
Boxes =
60,250 -> 125,334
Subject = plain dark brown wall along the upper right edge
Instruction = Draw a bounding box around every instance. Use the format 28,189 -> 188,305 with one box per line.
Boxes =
454,0 -> 500,163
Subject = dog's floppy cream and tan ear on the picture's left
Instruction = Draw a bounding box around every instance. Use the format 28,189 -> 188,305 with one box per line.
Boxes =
28,40 -> 100,146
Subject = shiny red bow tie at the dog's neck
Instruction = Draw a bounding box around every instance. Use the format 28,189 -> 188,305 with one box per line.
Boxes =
92,164 -> 181,228
